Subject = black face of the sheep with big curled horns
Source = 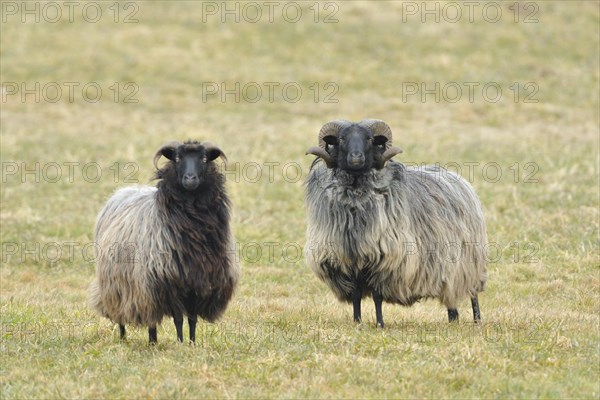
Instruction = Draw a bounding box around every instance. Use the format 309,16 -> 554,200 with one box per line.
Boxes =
323,125 -> 387,174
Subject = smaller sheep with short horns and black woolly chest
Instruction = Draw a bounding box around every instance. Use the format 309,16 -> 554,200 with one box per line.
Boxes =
90,141 -> 239,343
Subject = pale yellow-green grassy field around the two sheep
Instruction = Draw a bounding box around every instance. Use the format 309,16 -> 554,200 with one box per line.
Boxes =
0,1 -> 600,399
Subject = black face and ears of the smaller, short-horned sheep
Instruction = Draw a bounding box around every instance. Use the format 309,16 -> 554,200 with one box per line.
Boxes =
162,144 -> 222,192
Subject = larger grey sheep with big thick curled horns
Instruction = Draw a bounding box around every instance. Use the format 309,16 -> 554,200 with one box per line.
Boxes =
304,119 -> 487,327
